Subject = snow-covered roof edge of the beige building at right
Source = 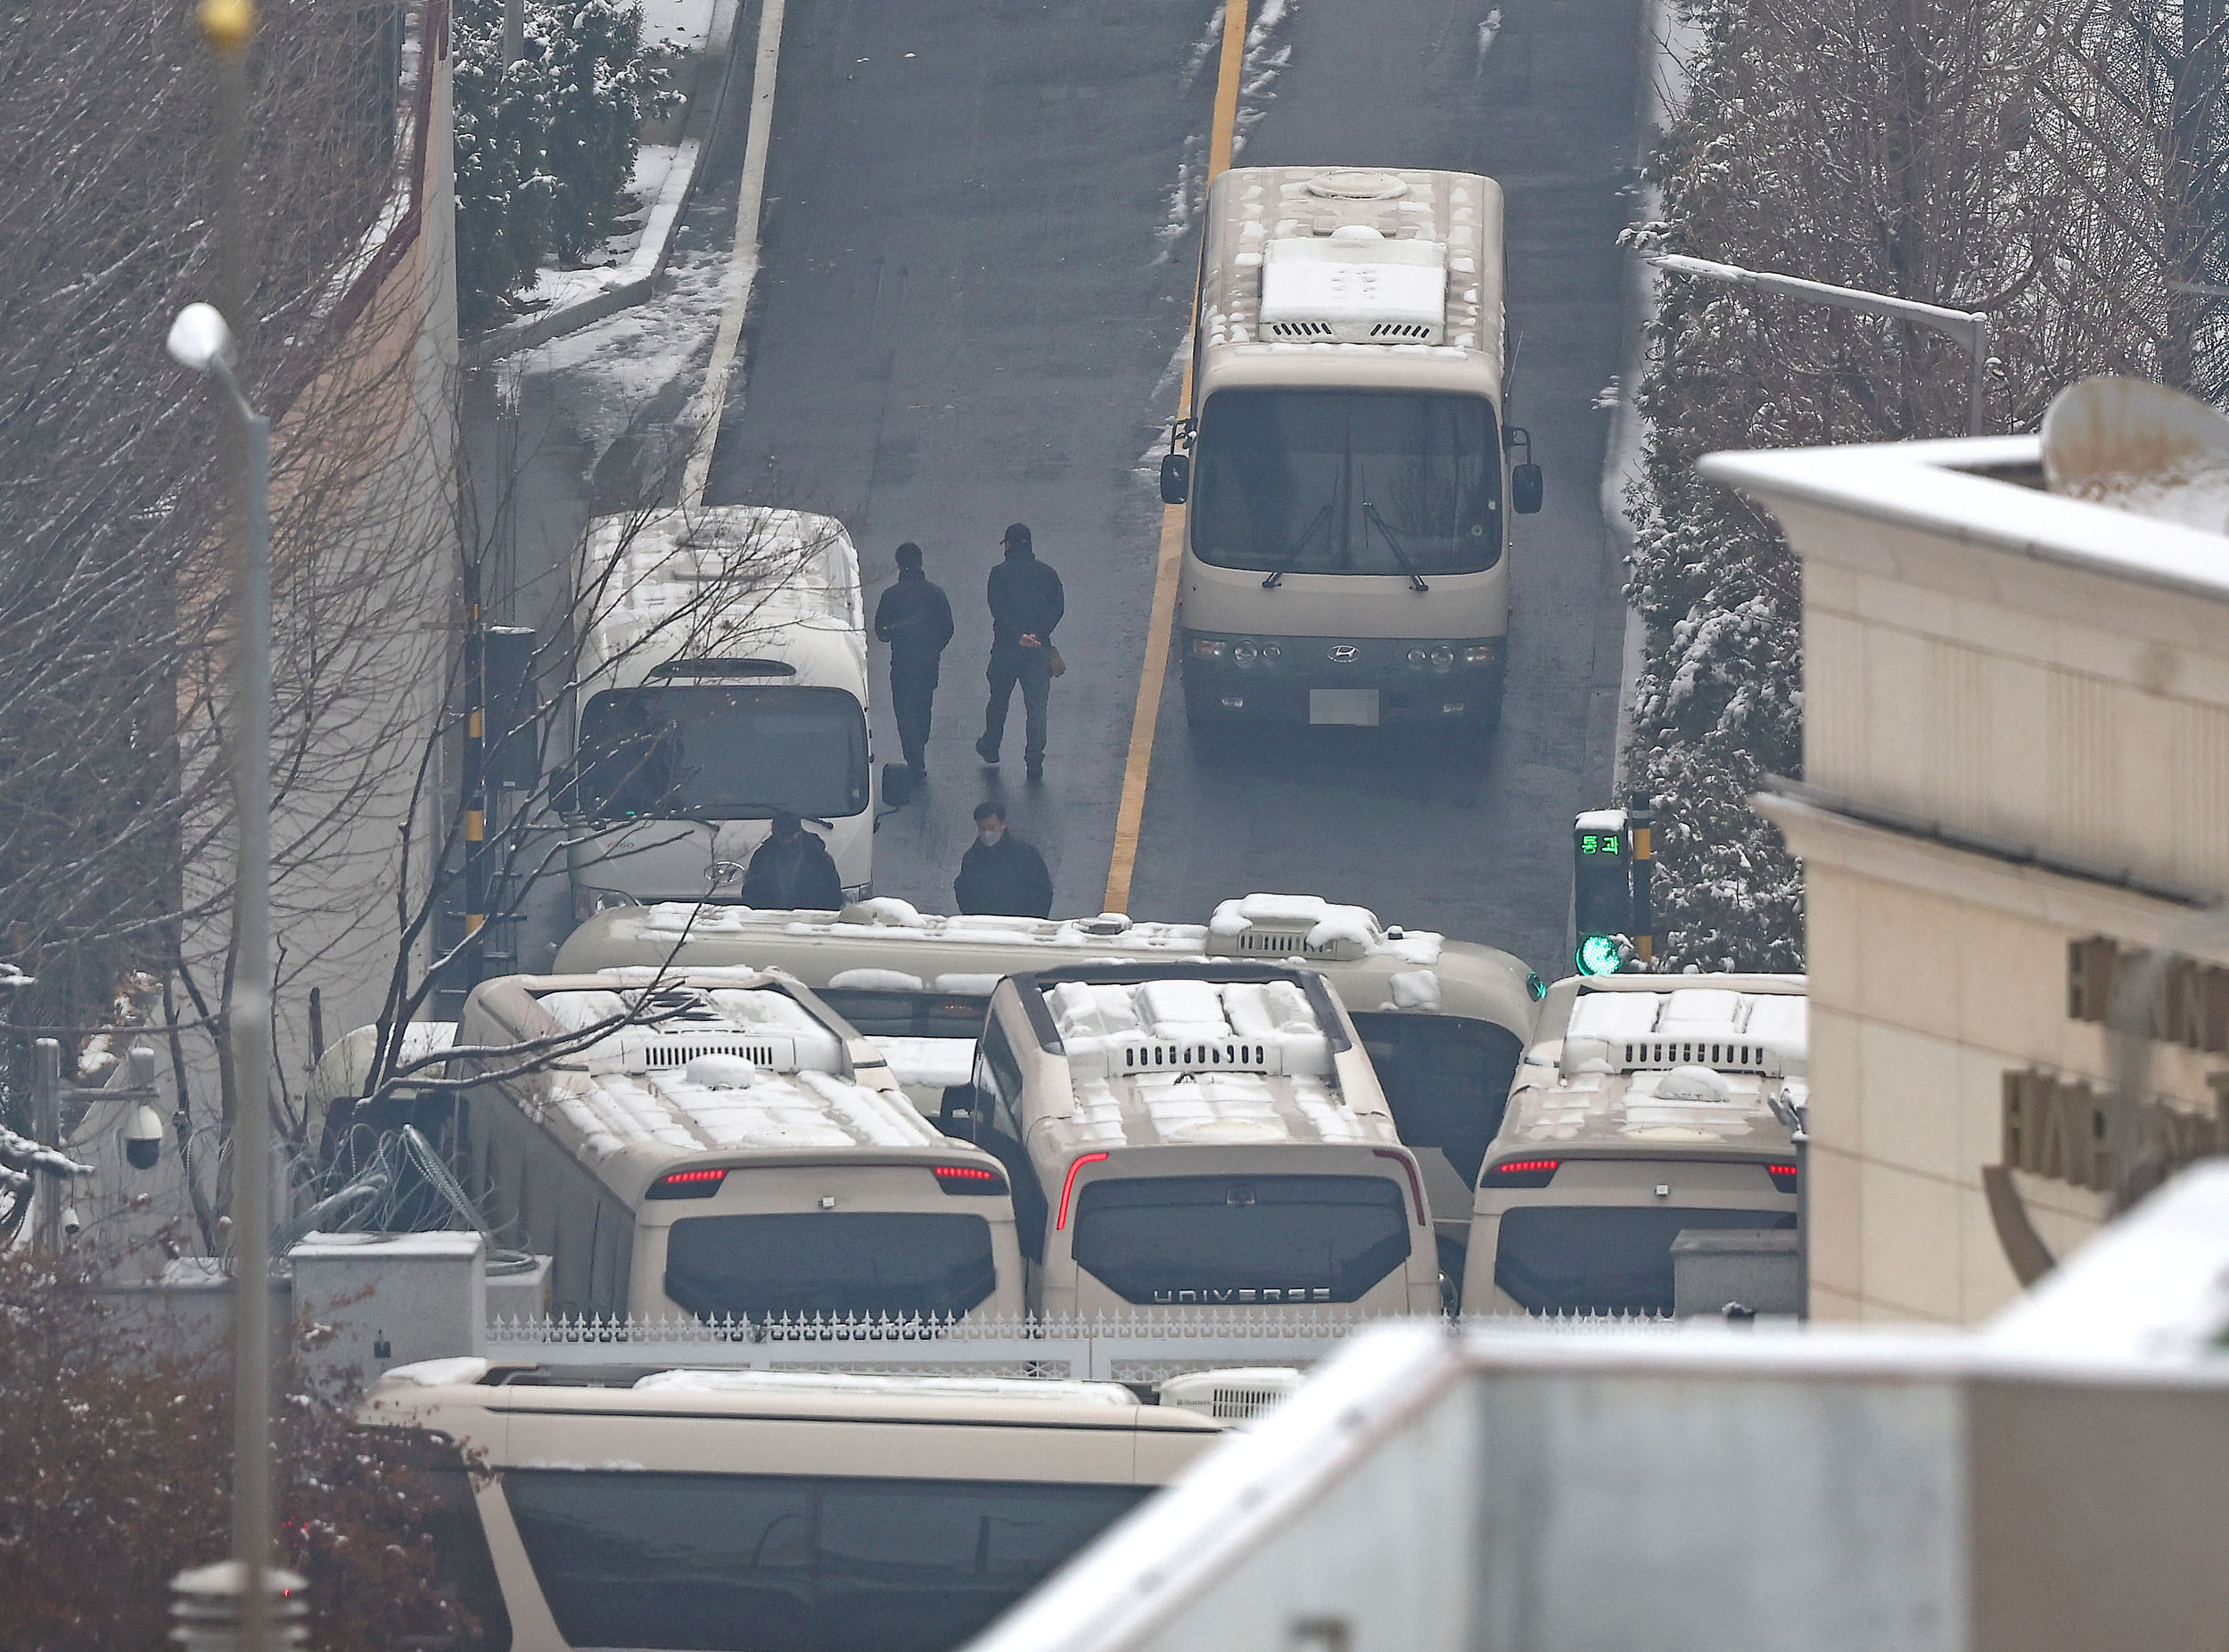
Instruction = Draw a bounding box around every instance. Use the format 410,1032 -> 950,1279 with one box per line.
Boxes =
1697,437 -> 2229,602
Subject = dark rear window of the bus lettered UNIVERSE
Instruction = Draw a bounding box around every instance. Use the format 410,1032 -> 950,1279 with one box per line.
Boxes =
1074,1175 -> 1411,1304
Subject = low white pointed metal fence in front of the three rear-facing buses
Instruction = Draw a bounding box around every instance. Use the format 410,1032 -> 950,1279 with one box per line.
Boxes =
481,1309 -> 1672,1382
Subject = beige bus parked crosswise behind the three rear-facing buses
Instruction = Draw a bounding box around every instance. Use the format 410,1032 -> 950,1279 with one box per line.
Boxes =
555,894 -> 1547,1278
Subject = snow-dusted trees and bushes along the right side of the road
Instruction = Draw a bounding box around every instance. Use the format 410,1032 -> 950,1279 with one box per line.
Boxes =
1625,0 -> 2225,970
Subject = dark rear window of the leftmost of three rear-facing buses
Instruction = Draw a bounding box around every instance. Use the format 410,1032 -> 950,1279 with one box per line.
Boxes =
667,1204 -> 999,1319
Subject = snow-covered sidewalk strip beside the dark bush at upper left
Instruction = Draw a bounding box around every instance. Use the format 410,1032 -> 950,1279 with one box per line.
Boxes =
464,0 -> 743,368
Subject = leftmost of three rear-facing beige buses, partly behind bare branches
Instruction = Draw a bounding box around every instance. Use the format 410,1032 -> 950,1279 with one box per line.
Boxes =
450,970 -> 1024,1324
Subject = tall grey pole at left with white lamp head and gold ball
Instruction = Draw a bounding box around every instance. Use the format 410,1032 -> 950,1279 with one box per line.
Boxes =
168,0 -> 285,1652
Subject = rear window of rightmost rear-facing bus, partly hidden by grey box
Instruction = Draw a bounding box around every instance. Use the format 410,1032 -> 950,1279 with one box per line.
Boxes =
1493,1204 -> 1797,1315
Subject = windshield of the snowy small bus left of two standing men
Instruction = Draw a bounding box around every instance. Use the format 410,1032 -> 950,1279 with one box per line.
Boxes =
569,685 -> 868,820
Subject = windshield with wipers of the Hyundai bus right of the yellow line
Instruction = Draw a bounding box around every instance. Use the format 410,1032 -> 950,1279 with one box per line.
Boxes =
1193,390 -> 1502,578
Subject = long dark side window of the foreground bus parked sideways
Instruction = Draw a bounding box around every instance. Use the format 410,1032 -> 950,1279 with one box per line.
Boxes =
504,1469 -> 1153,1652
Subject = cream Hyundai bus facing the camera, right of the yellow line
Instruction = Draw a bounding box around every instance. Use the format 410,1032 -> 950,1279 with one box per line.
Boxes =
1162,168 -> 1541,727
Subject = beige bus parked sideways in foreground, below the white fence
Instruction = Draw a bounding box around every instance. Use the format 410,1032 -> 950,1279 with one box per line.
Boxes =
361,1349 -> 1224,1652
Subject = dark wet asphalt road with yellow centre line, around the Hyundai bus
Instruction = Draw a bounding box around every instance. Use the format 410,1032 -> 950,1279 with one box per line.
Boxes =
709,0 -> 1641,974
